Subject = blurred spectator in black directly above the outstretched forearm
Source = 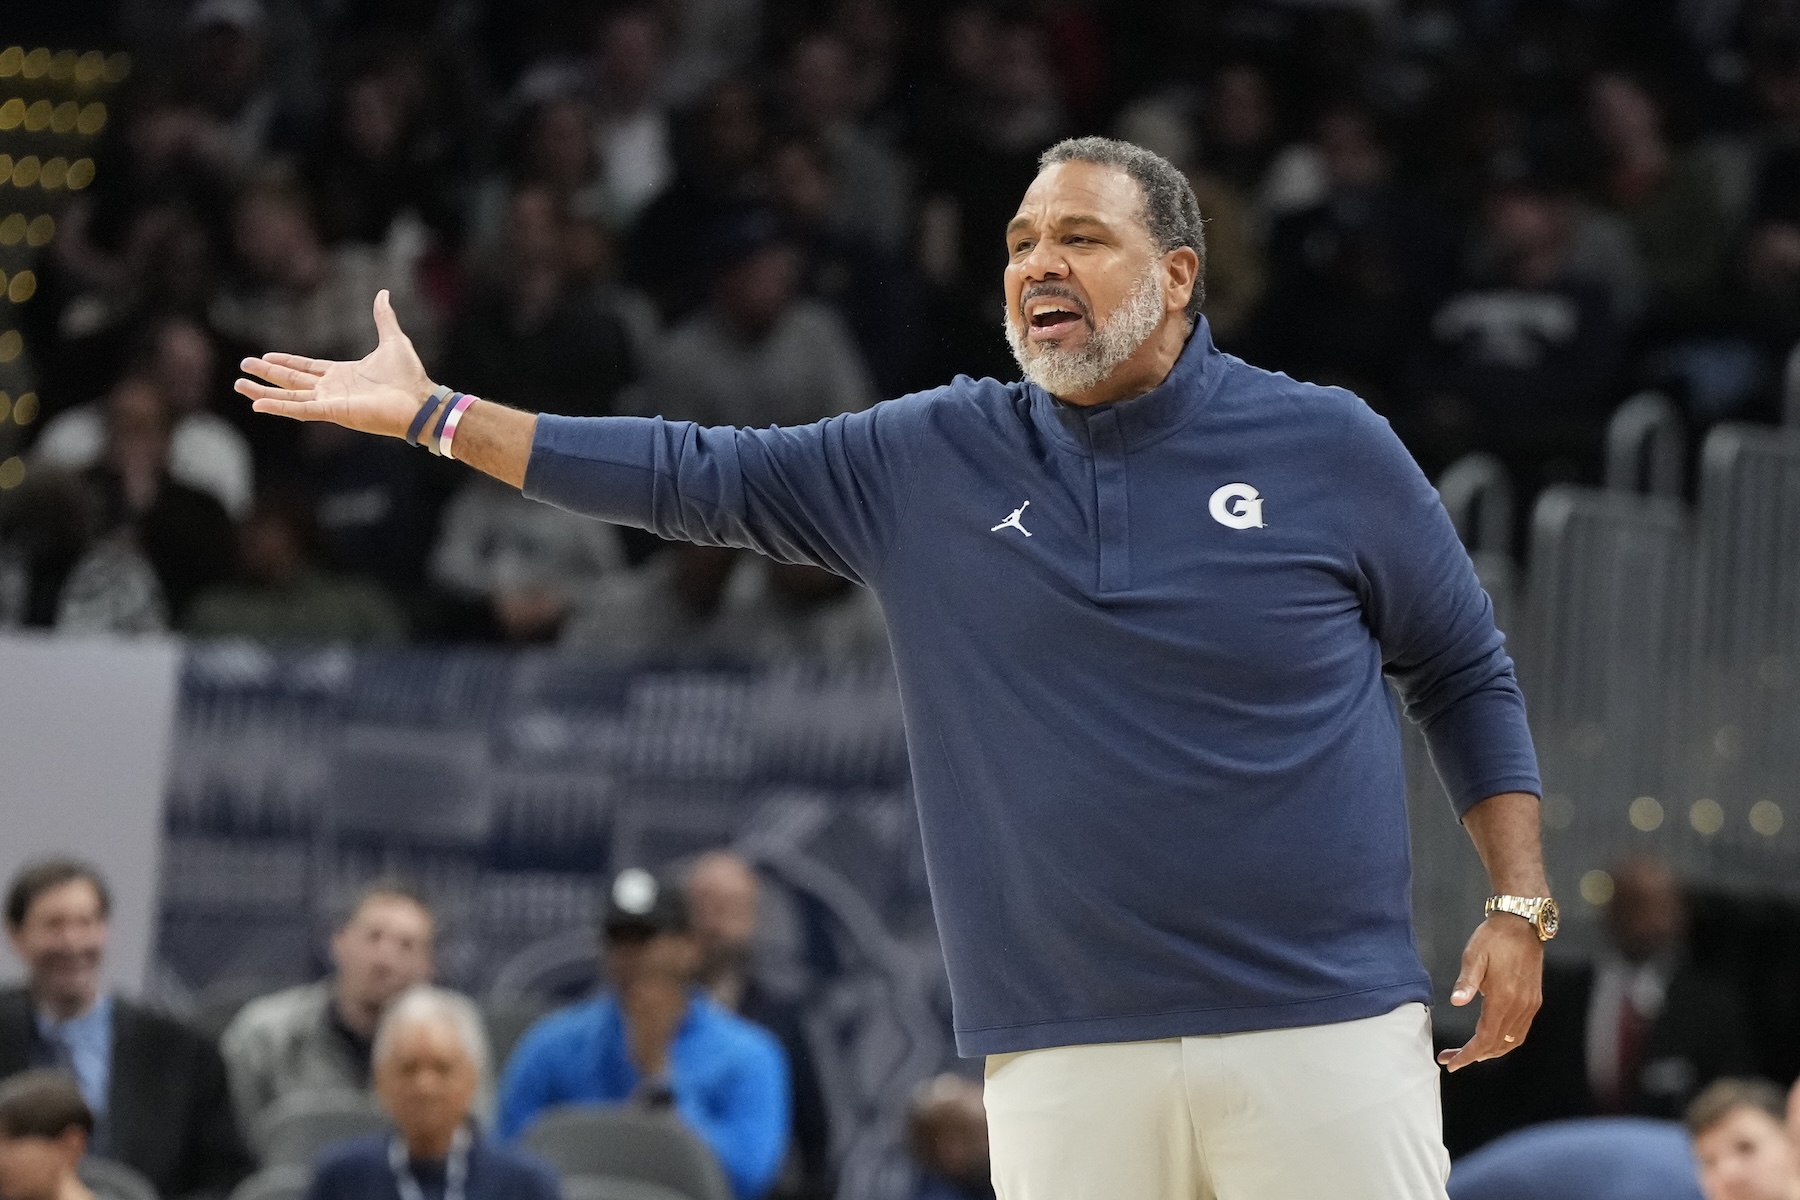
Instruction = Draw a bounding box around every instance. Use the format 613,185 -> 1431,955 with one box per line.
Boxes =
445,185 -> 637,417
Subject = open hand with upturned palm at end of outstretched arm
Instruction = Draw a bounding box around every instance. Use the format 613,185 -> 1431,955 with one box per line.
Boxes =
234,290 -> 432,437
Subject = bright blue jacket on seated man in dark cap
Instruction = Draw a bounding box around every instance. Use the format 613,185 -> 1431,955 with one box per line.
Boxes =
499,993 -> 792,1200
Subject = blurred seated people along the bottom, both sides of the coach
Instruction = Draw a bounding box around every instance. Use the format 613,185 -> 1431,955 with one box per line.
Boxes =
10,849 -> 1800,1200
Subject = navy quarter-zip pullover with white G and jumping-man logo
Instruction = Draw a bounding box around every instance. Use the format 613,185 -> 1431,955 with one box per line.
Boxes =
526,322 -> 1539,1054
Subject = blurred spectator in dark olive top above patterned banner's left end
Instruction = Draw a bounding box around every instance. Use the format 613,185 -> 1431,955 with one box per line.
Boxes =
184,497 -> 407,642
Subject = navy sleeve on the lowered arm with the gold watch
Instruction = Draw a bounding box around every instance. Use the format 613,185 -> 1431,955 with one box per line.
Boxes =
1343,403 -> 1541,815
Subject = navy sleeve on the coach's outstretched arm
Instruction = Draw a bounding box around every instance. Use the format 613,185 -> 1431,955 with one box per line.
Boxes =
524,399 -> 911,583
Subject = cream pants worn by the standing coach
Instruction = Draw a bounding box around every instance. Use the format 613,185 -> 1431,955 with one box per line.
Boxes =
986,1004 -> 1451,1200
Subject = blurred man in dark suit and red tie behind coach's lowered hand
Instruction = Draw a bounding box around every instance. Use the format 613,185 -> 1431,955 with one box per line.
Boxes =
1444,858 -> 1751,1155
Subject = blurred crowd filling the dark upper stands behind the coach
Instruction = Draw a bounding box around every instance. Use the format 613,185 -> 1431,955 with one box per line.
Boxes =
0,0 -> 1800,644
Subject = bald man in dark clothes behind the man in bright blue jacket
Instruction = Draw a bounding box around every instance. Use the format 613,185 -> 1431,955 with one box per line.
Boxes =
682,849 -> 837,1196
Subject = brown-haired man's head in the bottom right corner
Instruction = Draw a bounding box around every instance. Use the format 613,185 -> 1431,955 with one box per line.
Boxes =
1685,1078 -> 1800,1200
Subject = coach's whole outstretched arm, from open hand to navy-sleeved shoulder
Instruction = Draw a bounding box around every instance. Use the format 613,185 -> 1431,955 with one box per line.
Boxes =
236,291 -> 918,583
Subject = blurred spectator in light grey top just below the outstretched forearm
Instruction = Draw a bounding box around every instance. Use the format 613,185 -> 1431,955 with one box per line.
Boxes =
430,477 -> 625,642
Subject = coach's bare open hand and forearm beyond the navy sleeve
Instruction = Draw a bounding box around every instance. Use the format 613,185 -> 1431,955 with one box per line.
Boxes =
236,291 -> 538,488
